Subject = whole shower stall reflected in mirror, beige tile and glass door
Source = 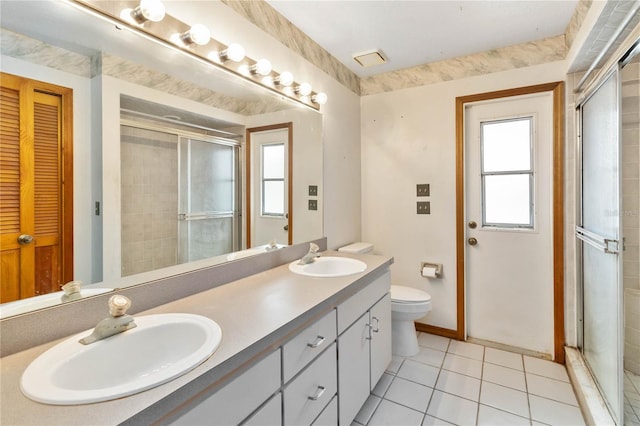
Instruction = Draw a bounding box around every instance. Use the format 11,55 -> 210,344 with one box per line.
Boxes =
120,117 -> 241,276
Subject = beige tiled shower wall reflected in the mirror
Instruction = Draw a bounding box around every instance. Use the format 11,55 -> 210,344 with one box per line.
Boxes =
120,126 -> 178,276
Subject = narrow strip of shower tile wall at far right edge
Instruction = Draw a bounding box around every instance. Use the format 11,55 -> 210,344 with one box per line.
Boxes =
622,62 -> 640,374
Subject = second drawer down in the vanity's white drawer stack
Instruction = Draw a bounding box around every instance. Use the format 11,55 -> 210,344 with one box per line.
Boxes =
284,342 -> 338,426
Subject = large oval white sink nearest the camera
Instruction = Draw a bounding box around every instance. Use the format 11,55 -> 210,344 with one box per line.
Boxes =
20,314 -> 222,405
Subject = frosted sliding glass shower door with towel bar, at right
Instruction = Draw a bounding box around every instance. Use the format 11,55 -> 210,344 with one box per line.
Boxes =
576,70 -> 622,423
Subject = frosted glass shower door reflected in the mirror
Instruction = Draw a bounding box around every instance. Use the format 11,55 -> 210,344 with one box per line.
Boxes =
178,138 -> 239,263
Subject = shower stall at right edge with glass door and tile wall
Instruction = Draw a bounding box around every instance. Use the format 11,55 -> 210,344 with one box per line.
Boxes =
576,40 -> 640,425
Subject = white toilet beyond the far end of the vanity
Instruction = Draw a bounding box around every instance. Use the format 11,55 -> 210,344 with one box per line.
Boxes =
338,243 -> 431,356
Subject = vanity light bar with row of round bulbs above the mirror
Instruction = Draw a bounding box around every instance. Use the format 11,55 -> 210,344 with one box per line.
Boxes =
72,0 -> 327,110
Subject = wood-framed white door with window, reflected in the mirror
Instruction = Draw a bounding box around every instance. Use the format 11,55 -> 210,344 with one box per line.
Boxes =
247,124 -> 292,247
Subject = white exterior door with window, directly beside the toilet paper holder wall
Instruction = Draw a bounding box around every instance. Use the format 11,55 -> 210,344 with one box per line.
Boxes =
465,92 -> 554,357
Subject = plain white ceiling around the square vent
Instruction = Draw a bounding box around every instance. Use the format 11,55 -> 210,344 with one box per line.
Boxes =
266,0 -> 578,77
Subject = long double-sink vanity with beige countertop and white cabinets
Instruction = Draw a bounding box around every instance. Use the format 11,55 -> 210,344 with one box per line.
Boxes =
1,243 -> 393,425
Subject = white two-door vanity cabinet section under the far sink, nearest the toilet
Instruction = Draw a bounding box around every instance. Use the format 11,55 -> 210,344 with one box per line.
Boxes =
338,272 -> 391,425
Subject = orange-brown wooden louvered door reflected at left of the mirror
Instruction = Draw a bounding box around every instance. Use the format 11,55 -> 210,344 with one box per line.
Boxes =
0,73 -> 73,303
